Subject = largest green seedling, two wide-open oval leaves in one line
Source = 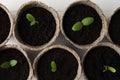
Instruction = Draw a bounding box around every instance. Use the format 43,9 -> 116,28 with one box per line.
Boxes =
72,17 -> 94,31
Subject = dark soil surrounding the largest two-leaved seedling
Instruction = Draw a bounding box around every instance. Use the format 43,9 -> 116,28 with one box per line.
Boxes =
62,4 -> 102,45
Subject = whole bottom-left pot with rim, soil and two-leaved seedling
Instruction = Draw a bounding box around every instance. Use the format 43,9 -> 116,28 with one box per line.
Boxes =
0,45 -> 33,80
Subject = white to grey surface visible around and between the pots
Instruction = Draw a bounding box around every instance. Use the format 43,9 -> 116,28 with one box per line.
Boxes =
0,0 -> 120,80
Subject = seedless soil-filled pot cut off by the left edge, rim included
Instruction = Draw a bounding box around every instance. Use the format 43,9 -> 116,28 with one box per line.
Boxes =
0,4 -> 14,47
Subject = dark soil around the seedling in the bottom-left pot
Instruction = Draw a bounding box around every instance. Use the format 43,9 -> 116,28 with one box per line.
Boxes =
0,48 -> 29,80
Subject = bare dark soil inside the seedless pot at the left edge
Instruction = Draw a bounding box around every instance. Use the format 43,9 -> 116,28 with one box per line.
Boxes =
0,7 -> 11,43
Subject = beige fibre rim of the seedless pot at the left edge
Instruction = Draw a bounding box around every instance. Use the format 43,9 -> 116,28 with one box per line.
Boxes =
0,3 -> 15,47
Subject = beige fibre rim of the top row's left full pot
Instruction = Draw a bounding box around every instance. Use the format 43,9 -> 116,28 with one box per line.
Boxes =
13,1 -> 60,51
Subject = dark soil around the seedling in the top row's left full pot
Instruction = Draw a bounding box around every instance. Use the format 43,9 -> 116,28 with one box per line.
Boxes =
16,7 -> 56,46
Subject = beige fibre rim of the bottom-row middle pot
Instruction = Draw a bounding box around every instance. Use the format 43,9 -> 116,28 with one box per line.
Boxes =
33,45 -> 82,80
